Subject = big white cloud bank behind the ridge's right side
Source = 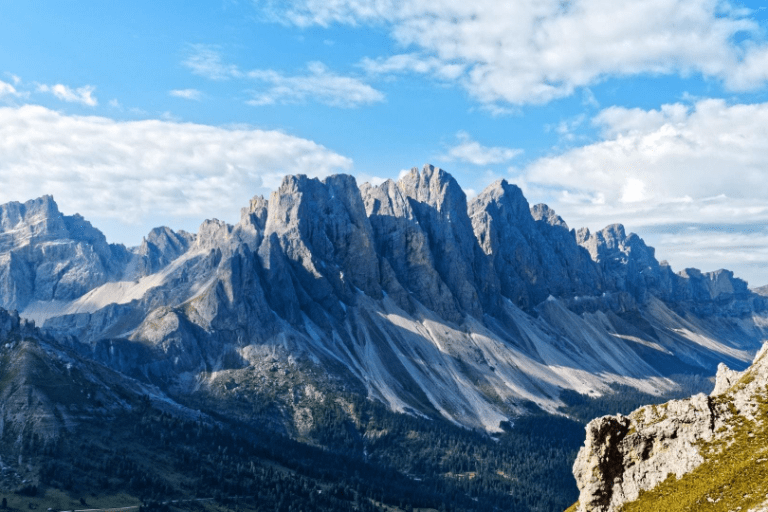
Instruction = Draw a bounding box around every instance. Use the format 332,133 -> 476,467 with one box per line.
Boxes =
511,99 -> 768,285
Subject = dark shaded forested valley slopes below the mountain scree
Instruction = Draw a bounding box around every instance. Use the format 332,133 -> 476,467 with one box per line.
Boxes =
6,395 -> 583,512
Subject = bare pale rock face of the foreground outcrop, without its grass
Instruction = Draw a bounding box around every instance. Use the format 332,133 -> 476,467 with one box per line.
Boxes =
573,344 -> 768,512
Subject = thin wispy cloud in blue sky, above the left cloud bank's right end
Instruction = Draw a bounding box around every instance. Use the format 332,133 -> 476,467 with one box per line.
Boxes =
248,62 -> 384,108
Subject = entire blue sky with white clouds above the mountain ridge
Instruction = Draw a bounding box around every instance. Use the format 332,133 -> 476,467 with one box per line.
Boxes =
0,0 -> 768,286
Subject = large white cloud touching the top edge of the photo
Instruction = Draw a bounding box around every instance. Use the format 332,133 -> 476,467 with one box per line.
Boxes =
258,0 -> 768,105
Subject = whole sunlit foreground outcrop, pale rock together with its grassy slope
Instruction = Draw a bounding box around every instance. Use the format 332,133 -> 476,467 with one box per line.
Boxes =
573,344 -> 768,512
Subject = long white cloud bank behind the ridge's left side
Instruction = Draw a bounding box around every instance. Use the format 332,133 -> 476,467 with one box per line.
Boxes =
0,105 -> 352,241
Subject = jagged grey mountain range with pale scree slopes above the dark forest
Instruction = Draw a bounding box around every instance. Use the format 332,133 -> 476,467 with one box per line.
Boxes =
0,166 -> 768,431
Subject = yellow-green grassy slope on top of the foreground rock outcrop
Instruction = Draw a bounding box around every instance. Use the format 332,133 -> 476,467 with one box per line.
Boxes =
622,387 -> 768,512
